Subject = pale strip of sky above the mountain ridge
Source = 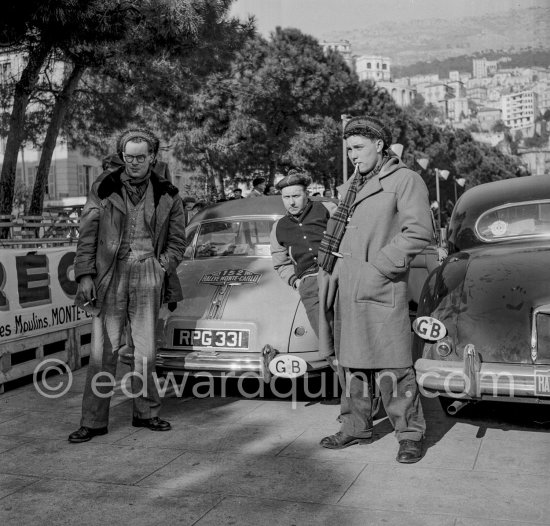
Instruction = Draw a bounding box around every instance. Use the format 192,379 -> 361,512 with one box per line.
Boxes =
231,0 -> 550,38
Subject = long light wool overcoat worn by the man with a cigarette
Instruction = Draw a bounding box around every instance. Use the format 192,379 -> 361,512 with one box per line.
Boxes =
319,157 -> 433,369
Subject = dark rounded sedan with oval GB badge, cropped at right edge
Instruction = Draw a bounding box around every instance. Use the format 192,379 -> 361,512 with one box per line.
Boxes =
414,176 -> 550,414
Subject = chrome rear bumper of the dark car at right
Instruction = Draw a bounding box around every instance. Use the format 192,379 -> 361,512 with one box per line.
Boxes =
415,346 -> 550,403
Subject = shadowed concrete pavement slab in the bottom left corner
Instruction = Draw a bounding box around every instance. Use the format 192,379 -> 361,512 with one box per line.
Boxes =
0,480 -> 224,526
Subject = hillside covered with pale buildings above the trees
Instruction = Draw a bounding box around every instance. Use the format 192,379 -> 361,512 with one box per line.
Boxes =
321,40 -> 550,174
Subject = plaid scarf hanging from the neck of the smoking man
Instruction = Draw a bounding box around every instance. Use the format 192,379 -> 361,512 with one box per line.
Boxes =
317,154 -> 390,273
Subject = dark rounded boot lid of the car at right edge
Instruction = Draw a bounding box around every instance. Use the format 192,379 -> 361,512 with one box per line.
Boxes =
446,243 -> 550,363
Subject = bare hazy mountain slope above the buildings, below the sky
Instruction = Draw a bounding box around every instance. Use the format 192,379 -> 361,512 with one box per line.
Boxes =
323,5 -> 550,65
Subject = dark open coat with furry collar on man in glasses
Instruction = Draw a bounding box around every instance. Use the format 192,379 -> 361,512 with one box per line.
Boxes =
74,167 -> 186,310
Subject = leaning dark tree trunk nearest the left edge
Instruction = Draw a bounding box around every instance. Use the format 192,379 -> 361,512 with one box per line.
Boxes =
0,42 -> 52,224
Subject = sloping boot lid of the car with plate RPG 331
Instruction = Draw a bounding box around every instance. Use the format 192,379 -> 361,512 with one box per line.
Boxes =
169,256 -> 300,350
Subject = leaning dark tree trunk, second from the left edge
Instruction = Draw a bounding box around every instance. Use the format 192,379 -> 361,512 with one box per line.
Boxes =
29,64 -> 86,215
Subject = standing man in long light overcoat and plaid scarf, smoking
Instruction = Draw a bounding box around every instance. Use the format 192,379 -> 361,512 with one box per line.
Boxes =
319,117 -> 433,463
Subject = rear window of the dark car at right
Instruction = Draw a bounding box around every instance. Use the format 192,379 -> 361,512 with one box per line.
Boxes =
476,201 -> 550,241
